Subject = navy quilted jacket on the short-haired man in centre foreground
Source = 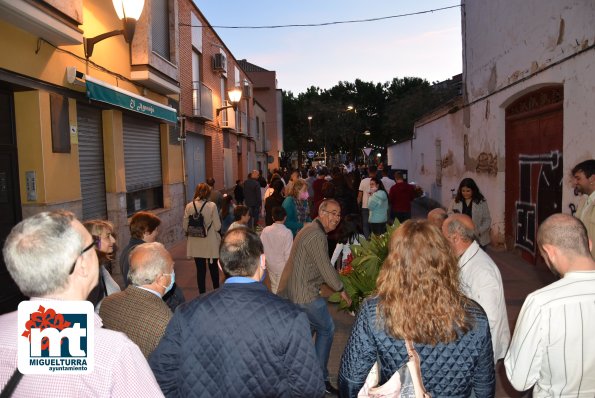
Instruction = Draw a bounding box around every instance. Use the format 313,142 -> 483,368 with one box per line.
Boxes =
149,283 -> 324,398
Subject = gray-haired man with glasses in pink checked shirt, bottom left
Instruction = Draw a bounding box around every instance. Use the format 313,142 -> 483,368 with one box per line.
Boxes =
0,211 -> 161,397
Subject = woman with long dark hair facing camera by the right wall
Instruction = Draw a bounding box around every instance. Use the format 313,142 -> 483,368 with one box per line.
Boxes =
447,178 -> 492,249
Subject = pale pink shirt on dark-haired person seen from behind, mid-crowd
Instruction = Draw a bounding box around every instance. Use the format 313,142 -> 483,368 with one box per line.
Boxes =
260,222 -> 293,274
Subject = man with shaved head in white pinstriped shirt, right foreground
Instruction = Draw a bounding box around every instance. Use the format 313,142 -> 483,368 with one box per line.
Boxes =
504,214 -> 595,397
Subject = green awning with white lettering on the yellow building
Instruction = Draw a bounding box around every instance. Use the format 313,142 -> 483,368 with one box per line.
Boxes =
85,76 -> 178,123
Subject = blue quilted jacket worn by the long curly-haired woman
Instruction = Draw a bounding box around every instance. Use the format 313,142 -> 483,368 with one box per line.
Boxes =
339,297 -> 495,398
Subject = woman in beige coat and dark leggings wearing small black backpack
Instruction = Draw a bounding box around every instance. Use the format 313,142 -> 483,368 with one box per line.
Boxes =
182,183 -> 221,294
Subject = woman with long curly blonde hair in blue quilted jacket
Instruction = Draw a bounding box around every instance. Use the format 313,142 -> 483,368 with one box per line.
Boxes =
339,220 -> 495,398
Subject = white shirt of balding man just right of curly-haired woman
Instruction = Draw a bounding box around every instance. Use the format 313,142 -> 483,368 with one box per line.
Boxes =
459,241 -> 510,362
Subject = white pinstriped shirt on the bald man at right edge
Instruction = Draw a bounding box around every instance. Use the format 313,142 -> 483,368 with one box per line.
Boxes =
504,271 -> 595,398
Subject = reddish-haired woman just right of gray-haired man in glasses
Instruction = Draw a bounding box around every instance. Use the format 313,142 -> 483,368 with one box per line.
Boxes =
83,220 -> 120,311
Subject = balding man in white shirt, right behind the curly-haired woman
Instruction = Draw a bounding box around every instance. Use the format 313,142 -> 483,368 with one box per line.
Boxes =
442,214 -> 510,362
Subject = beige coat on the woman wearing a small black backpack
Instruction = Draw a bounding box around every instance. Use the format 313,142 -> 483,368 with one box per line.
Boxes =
183,200 -> 221,258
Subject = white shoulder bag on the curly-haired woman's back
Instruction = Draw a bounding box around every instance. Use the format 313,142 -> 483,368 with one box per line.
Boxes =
357,340 -> 432,398
